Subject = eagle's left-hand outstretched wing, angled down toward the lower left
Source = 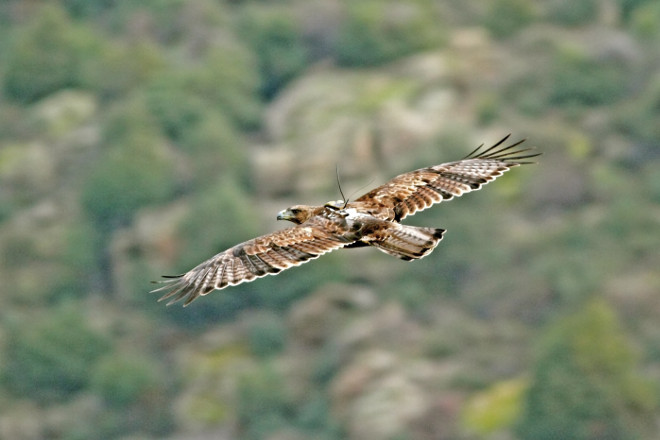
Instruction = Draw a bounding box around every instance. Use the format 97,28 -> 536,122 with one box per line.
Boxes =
152,226 -> 348,306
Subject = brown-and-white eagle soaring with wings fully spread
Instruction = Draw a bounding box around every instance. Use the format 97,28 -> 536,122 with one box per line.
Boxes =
152,135 -> 541,306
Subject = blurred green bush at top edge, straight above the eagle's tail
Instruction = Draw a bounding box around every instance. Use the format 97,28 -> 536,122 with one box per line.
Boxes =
335,0 -> 442,66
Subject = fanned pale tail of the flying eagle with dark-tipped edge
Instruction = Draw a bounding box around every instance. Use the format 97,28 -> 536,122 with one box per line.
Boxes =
369,223 -> 445,261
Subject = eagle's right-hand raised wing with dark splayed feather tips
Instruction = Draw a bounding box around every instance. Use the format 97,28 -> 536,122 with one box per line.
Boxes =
352,135 -> 540,221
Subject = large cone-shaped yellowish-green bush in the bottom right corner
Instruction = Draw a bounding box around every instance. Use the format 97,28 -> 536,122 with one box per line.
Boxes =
517,301 -> 656,440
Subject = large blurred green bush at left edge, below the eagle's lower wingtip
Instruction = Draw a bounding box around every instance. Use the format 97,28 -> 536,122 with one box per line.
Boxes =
2,305 -> 110,403
